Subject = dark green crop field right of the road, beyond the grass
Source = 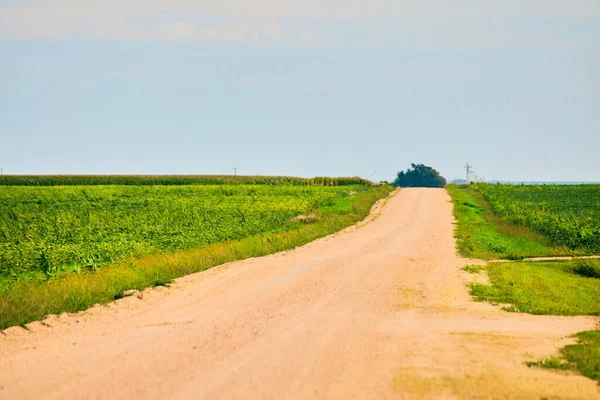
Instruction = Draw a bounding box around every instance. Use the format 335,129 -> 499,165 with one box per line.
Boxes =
473,184 -> 600,254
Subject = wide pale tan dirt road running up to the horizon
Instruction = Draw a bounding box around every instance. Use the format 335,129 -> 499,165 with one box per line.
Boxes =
0,189 -> 600,400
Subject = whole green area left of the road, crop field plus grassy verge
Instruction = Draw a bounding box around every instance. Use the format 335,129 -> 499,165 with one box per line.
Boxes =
0,178 -> 393,329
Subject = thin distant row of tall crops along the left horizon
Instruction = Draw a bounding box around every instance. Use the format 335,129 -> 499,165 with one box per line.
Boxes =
0,175 -> 372,186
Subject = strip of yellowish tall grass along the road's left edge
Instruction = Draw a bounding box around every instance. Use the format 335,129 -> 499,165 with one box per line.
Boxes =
0,186 -> 393,329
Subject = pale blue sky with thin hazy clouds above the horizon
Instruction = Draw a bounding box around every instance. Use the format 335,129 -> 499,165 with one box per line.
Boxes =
0,0 -> 600,181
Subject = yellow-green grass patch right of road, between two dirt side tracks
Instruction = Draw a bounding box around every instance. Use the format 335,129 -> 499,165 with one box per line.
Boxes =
470,261 -> 600,315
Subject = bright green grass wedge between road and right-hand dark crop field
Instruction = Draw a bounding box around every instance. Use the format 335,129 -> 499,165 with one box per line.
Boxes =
447,185 -> 578,260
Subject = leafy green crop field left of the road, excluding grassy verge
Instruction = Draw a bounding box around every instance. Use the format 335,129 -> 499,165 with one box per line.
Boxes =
0,185 -> 366,277
